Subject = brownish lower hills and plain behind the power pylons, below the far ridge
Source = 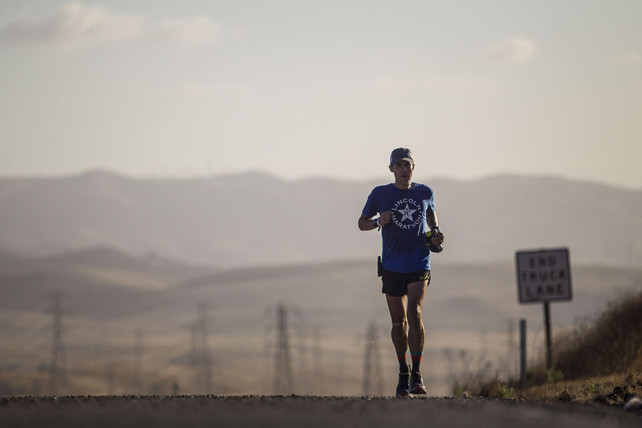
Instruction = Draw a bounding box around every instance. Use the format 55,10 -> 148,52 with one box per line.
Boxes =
0,248 -> 640,394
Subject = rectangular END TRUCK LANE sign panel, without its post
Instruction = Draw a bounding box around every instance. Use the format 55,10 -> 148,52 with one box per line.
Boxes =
515,248 -> 573,303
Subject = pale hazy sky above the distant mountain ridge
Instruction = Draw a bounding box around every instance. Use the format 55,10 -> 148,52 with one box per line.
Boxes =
0,0 -> 642,189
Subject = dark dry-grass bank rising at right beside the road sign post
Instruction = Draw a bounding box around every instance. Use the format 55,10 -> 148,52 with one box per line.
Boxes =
473,292 -> 642,405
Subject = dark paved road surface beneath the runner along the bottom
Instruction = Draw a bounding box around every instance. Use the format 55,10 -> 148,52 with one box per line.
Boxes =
0,396 -> 642,428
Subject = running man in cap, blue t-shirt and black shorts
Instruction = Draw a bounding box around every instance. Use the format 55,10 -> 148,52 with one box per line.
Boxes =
359,148 -> 444,397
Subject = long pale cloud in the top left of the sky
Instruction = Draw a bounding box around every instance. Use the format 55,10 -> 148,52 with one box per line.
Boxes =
0,3 -> 218,49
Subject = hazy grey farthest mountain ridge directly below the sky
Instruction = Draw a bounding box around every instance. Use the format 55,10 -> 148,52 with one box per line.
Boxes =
0,171 -> 642,267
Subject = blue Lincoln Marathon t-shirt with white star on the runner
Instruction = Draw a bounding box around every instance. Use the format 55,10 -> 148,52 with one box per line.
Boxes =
363,183 -> 435,273
